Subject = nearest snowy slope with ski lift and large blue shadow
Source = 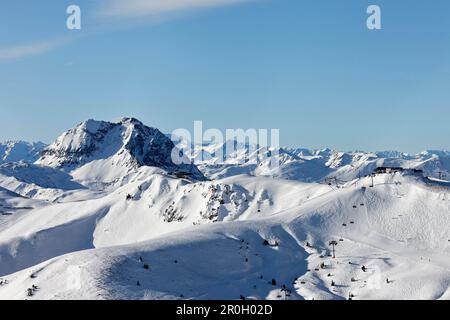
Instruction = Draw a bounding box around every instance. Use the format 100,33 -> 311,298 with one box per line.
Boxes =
0,175 -> 450,299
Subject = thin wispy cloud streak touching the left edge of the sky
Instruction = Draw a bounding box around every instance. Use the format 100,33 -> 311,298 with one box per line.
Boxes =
0,39 -> 67,62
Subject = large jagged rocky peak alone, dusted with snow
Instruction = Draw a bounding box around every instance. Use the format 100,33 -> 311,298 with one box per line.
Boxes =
36,118 -> 204,185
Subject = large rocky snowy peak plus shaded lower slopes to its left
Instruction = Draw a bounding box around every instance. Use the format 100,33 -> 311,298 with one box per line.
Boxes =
0,118 -> 205,201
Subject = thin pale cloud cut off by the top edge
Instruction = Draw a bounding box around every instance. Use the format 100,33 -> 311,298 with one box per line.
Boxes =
101,0 -> 255,18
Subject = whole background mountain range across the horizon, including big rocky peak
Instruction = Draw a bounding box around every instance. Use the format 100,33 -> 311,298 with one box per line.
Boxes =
0,118 -> 450,189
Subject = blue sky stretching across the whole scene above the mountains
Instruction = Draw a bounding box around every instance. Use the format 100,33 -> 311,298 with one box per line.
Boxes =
0,0 -> 450,152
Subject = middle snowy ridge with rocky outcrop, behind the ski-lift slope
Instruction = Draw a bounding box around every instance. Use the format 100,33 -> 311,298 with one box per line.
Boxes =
0,172 -> 330,275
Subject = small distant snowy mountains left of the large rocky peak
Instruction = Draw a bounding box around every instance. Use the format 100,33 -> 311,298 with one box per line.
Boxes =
0,141 -> 46,164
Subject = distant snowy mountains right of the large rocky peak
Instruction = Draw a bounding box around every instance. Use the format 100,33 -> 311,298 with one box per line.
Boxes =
192,144 -> 450,182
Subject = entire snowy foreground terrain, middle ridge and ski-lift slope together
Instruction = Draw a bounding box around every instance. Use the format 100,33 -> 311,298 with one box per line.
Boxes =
0,174 -> 450,300
